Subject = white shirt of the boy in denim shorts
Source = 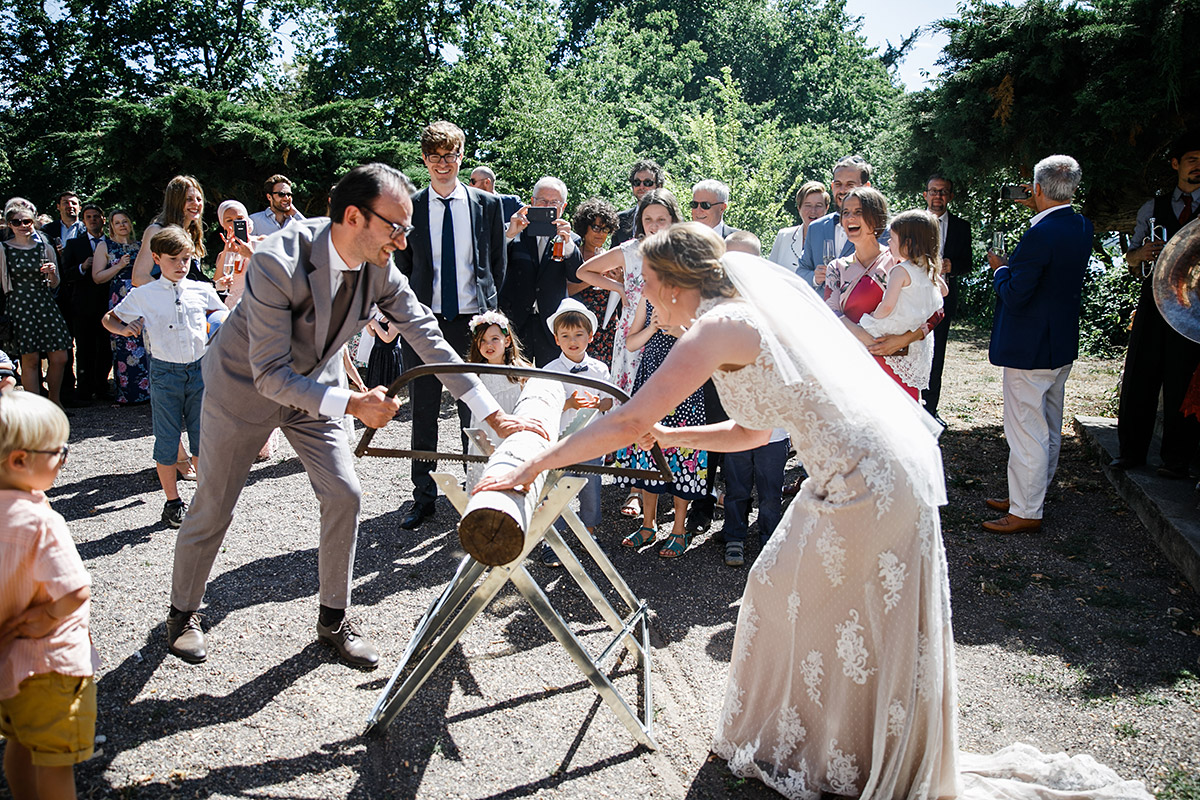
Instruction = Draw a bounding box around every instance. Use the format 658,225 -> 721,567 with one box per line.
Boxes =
113,277 -> 226,363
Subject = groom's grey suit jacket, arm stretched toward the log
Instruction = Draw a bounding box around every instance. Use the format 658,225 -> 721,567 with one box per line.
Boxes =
204,217 -> 480,422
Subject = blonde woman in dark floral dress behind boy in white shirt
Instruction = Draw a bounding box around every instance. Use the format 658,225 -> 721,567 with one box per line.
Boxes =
91,211 -> 150,405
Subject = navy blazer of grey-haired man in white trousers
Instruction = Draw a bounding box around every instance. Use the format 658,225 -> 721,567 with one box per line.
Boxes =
988,206 -> 1092,369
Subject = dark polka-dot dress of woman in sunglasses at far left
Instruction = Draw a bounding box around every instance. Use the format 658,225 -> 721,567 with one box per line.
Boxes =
4,242 -> 71,354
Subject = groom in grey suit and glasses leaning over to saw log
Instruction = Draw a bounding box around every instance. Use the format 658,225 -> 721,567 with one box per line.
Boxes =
167,164 -> 539,668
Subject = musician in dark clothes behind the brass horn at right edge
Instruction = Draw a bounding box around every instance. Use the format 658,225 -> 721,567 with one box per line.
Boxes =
1110,133 -> 1200,480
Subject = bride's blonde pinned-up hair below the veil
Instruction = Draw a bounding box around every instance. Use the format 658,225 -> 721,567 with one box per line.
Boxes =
642,222 -> 737,297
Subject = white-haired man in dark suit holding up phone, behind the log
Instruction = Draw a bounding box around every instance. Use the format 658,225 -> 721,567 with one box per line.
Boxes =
500,175 -> 583,367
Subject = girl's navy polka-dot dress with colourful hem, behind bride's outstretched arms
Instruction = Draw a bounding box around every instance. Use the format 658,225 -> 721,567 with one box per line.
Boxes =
618,303 -> 708,500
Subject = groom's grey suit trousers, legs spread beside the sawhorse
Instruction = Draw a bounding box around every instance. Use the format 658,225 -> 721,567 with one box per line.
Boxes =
170,397 -> 362,610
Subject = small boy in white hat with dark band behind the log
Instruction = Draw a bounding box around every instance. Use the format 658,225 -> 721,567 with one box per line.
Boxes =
541,297 -> 612,566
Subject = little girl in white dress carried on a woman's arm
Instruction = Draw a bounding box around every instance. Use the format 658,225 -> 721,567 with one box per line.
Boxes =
858,210 -> 948,393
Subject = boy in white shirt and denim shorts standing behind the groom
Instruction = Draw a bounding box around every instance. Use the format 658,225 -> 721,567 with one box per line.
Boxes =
102,225 -> 226,528
